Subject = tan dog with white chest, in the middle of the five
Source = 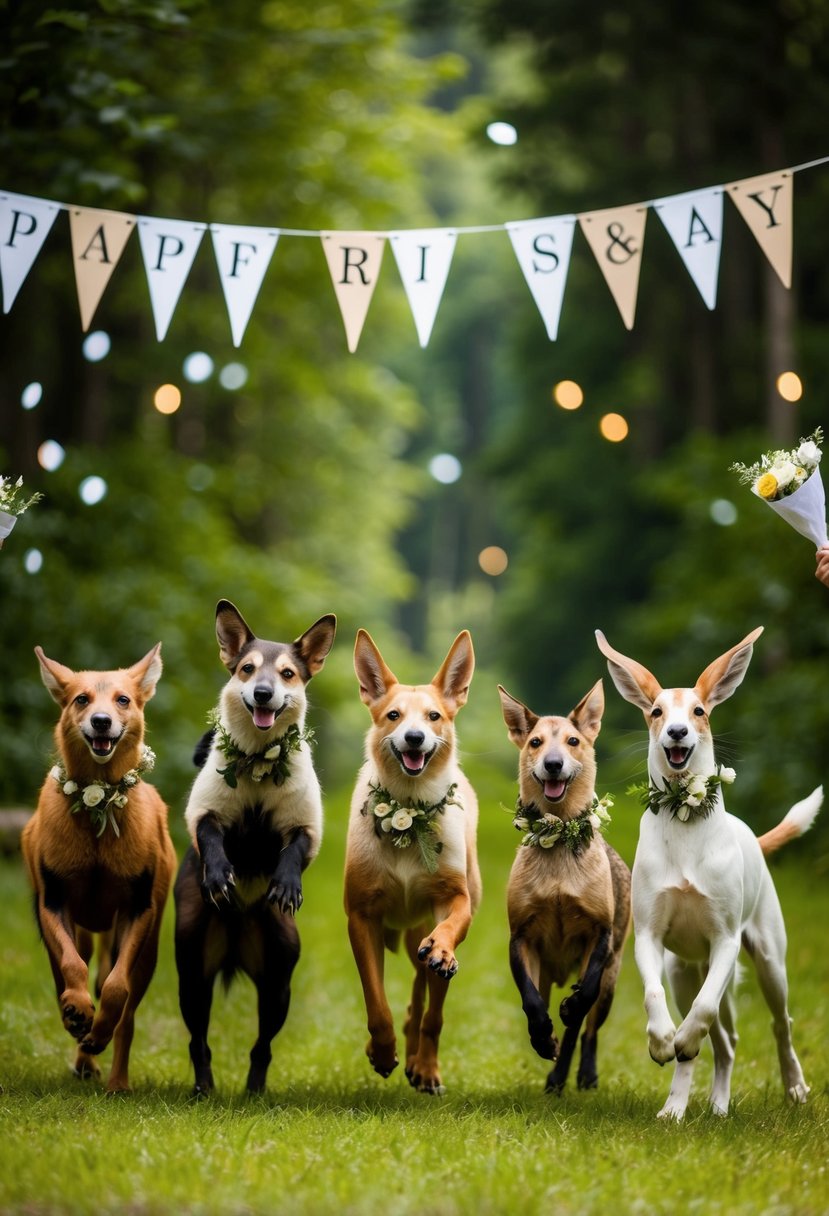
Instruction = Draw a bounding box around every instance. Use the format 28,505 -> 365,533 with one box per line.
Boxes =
345,630 -> 481,1093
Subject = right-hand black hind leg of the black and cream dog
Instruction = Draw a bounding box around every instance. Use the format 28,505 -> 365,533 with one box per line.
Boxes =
239,906 -> 299,1093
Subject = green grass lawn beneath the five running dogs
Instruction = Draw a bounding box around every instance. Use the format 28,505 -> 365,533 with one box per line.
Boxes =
0,764 -> 829,1216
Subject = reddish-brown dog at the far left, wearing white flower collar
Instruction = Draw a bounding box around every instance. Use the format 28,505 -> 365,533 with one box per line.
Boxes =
22,643 -> 175,1093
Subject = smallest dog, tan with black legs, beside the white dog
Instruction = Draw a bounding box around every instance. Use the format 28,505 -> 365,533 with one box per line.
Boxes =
498,680 -> 631,1093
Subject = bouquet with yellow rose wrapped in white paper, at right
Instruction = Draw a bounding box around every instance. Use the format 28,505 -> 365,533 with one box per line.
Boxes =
731,427 -> 829,548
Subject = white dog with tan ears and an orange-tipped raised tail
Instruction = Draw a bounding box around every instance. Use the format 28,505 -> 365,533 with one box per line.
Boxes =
596,627 -> 823,1119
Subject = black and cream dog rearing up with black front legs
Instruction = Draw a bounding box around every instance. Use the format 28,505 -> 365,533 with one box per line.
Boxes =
174,599 -> 337,1094
